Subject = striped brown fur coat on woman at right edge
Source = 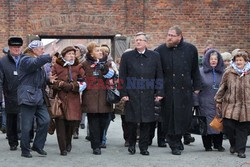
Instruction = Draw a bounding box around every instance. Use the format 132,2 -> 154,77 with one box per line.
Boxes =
214,67 -> 250,122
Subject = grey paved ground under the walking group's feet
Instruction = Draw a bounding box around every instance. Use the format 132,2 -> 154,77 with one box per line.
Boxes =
0,115 -> 250,167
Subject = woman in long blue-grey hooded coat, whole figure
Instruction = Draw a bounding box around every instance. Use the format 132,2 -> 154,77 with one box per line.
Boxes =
199,49 -> 225,151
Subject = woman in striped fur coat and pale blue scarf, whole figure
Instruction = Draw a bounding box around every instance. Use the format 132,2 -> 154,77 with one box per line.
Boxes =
214,49 -> 250,158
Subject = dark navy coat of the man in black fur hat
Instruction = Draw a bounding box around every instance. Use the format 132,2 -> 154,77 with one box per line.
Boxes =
0,53 -> 22,113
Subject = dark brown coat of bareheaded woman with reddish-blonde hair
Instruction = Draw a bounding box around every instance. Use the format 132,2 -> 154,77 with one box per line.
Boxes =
82,53 -> 112,113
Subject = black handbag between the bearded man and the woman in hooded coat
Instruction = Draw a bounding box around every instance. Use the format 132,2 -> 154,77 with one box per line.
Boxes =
188,107 -> 207,135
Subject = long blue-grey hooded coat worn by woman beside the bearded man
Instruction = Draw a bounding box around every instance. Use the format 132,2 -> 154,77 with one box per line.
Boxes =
199,49 -> 224,134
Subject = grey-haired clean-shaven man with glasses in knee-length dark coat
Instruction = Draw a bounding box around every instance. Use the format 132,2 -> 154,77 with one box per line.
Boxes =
120,33 -> 163,155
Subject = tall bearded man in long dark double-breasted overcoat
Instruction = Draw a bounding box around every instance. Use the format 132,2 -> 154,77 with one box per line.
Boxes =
155,26 -> 200,155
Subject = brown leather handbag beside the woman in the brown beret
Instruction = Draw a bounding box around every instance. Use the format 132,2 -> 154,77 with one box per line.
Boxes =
49,94 -> 63,118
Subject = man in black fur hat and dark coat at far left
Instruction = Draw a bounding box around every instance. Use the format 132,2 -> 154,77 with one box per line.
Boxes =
0,37 -> 23,151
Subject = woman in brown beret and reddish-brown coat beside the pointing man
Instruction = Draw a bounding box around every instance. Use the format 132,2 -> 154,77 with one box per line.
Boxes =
52,46 -> 86,156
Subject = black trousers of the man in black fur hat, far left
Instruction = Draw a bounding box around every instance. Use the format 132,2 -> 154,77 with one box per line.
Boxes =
6,113 -> 19,146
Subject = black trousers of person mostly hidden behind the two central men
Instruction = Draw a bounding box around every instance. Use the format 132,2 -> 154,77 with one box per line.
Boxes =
149,122 -> 166,144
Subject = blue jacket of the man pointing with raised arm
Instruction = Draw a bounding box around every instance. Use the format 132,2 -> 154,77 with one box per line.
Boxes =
17,55 -> 52,106
